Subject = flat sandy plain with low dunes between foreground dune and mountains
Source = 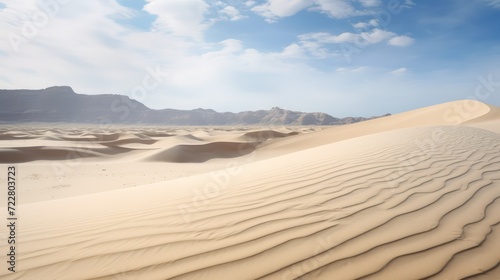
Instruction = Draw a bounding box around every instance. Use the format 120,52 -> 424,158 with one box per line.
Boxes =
0,124 -> 325,202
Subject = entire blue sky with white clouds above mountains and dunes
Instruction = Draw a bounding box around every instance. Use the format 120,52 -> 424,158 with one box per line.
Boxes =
0,0 -> 500,117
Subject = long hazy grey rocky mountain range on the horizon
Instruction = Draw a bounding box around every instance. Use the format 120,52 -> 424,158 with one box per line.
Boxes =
0,86 -> 390,125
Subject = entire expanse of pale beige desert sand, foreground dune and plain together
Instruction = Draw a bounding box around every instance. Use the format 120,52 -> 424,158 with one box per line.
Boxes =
0,101 -> 500,280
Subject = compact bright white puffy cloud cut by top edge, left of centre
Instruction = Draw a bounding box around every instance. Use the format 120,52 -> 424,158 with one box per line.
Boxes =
144,0 -> 209,40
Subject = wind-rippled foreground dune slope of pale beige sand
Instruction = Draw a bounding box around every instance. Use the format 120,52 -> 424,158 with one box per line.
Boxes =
0,127 -> 500,280
